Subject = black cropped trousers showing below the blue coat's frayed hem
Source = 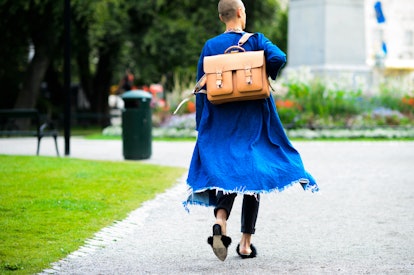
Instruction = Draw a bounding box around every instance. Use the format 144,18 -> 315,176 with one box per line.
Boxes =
214,191 -> 260,234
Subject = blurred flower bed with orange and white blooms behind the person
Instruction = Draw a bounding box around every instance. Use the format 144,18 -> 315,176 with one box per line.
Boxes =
104,73 -> 414,139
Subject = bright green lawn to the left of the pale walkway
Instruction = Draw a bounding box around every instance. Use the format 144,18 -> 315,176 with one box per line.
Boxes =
0,156 -> 185,274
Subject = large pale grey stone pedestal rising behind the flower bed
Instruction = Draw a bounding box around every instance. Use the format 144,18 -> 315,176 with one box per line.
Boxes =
287,0 -> 371,88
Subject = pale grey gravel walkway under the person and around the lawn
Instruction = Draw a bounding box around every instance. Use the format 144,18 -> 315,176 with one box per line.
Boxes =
0,138 -> 414,274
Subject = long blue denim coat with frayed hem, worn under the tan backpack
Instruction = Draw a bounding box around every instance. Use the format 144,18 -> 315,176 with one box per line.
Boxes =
184,32 -> 318,210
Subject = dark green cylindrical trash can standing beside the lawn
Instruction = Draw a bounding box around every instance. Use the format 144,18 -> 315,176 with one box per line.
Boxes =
121,90 -> 152,160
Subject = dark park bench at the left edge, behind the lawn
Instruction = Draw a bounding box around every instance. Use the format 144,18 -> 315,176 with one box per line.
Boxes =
0,109 -> 59,156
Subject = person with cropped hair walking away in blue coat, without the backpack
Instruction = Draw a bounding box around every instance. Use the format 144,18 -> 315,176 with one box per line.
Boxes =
184,0 -> 319,261
